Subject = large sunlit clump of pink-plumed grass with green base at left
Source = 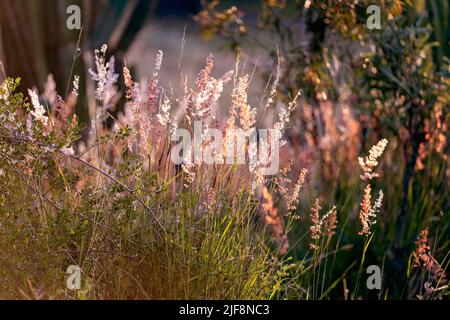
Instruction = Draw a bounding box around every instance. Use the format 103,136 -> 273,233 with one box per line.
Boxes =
0,46 -> 296,299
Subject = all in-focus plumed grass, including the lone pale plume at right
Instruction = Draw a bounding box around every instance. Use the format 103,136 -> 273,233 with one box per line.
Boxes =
0,46 -> 445,299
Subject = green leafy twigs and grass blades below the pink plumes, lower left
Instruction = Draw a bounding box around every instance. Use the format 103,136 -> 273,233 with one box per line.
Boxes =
0,79 -> 282,299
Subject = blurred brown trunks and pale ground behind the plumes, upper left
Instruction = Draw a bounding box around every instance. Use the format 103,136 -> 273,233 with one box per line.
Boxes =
0,0 -> 272,123
